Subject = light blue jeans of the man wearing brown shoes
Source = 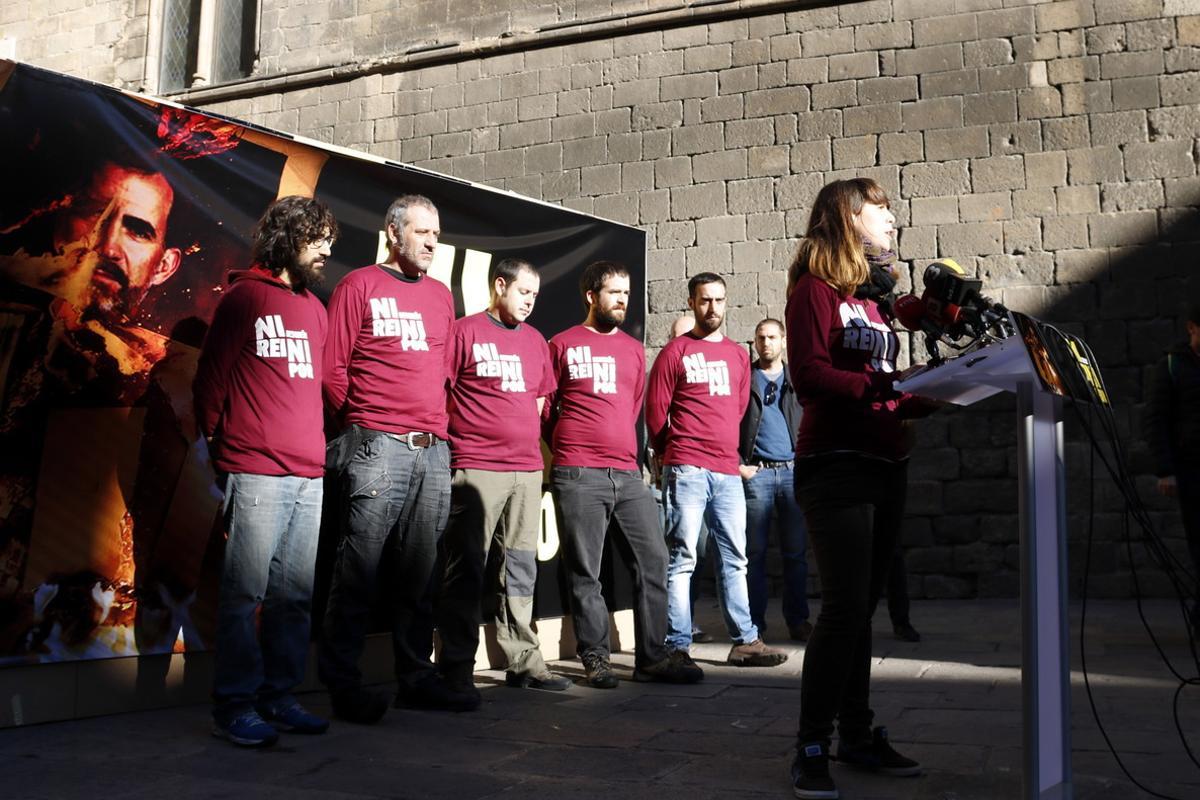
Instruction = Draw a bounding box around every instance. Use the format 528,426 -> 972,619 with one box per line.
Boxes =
662,464 -> 758,650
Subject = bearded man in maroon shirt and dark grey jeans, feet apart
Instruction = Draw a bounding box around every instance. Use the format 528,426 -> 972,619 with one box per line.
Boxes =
547,261 -> 704,688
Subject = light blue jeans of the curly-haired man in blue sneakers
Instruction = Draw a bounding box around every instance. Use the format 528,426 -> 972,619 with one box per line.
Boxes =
212,474 -> 323,723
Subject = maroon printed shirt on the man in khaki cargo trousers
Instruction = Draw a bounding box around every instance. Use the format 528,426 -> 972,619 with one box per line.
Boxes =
448,311 -> 554,473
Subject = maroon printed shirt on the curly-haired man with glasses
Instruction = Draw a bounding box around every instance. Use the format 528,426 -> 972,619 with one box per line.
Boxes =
192,269 -> 325,477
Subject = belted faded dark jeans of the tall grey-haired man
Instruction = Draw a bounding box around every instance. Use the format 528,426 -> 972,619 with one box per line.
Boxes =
317,431 -> 450,693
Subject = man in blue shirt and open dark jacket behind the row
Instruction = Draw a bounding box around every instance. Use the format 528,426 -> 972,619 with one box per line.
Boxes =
738,318 -> 812,642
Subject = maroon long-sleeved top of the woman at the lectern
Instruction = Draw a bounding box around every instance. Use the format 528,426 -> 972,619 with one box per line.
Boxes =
785,275 -> 930,459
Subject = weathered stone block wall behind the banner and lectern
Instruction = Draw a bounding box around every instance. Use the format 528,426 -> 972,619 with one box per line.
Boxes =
7,0 -> 1200,596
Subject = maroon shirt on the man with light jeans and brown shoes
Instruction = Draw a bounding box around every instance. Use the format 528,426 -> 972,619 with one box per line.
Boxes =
646,332 -> 750,475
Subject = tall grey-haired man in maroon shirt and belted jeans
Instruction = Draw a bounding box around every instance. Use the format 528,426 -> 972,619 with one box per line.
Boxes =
319,194 -> 479,723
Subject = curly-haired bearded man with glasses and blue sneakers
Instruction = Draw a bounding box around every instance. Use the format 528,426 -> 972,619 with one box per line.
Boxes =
193,197 -> 337,747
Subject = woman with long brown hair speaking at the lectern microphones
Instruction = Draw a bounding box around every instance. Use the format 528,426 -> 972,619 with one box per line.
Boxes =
786,178 -> 934,800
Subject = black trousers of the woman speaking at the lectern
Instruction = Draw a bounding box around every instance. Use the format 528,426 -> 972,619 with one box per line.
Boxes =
796,453 -> 907,745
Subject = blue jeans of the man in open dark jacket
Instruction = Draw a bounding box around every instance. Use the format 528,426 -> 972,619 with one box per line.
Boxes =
745,467 -> 809,633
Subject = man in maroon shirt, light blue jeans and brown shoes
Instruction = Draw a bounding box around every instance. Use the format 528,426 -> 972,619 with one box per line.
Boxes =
646,272 -> 787,667
